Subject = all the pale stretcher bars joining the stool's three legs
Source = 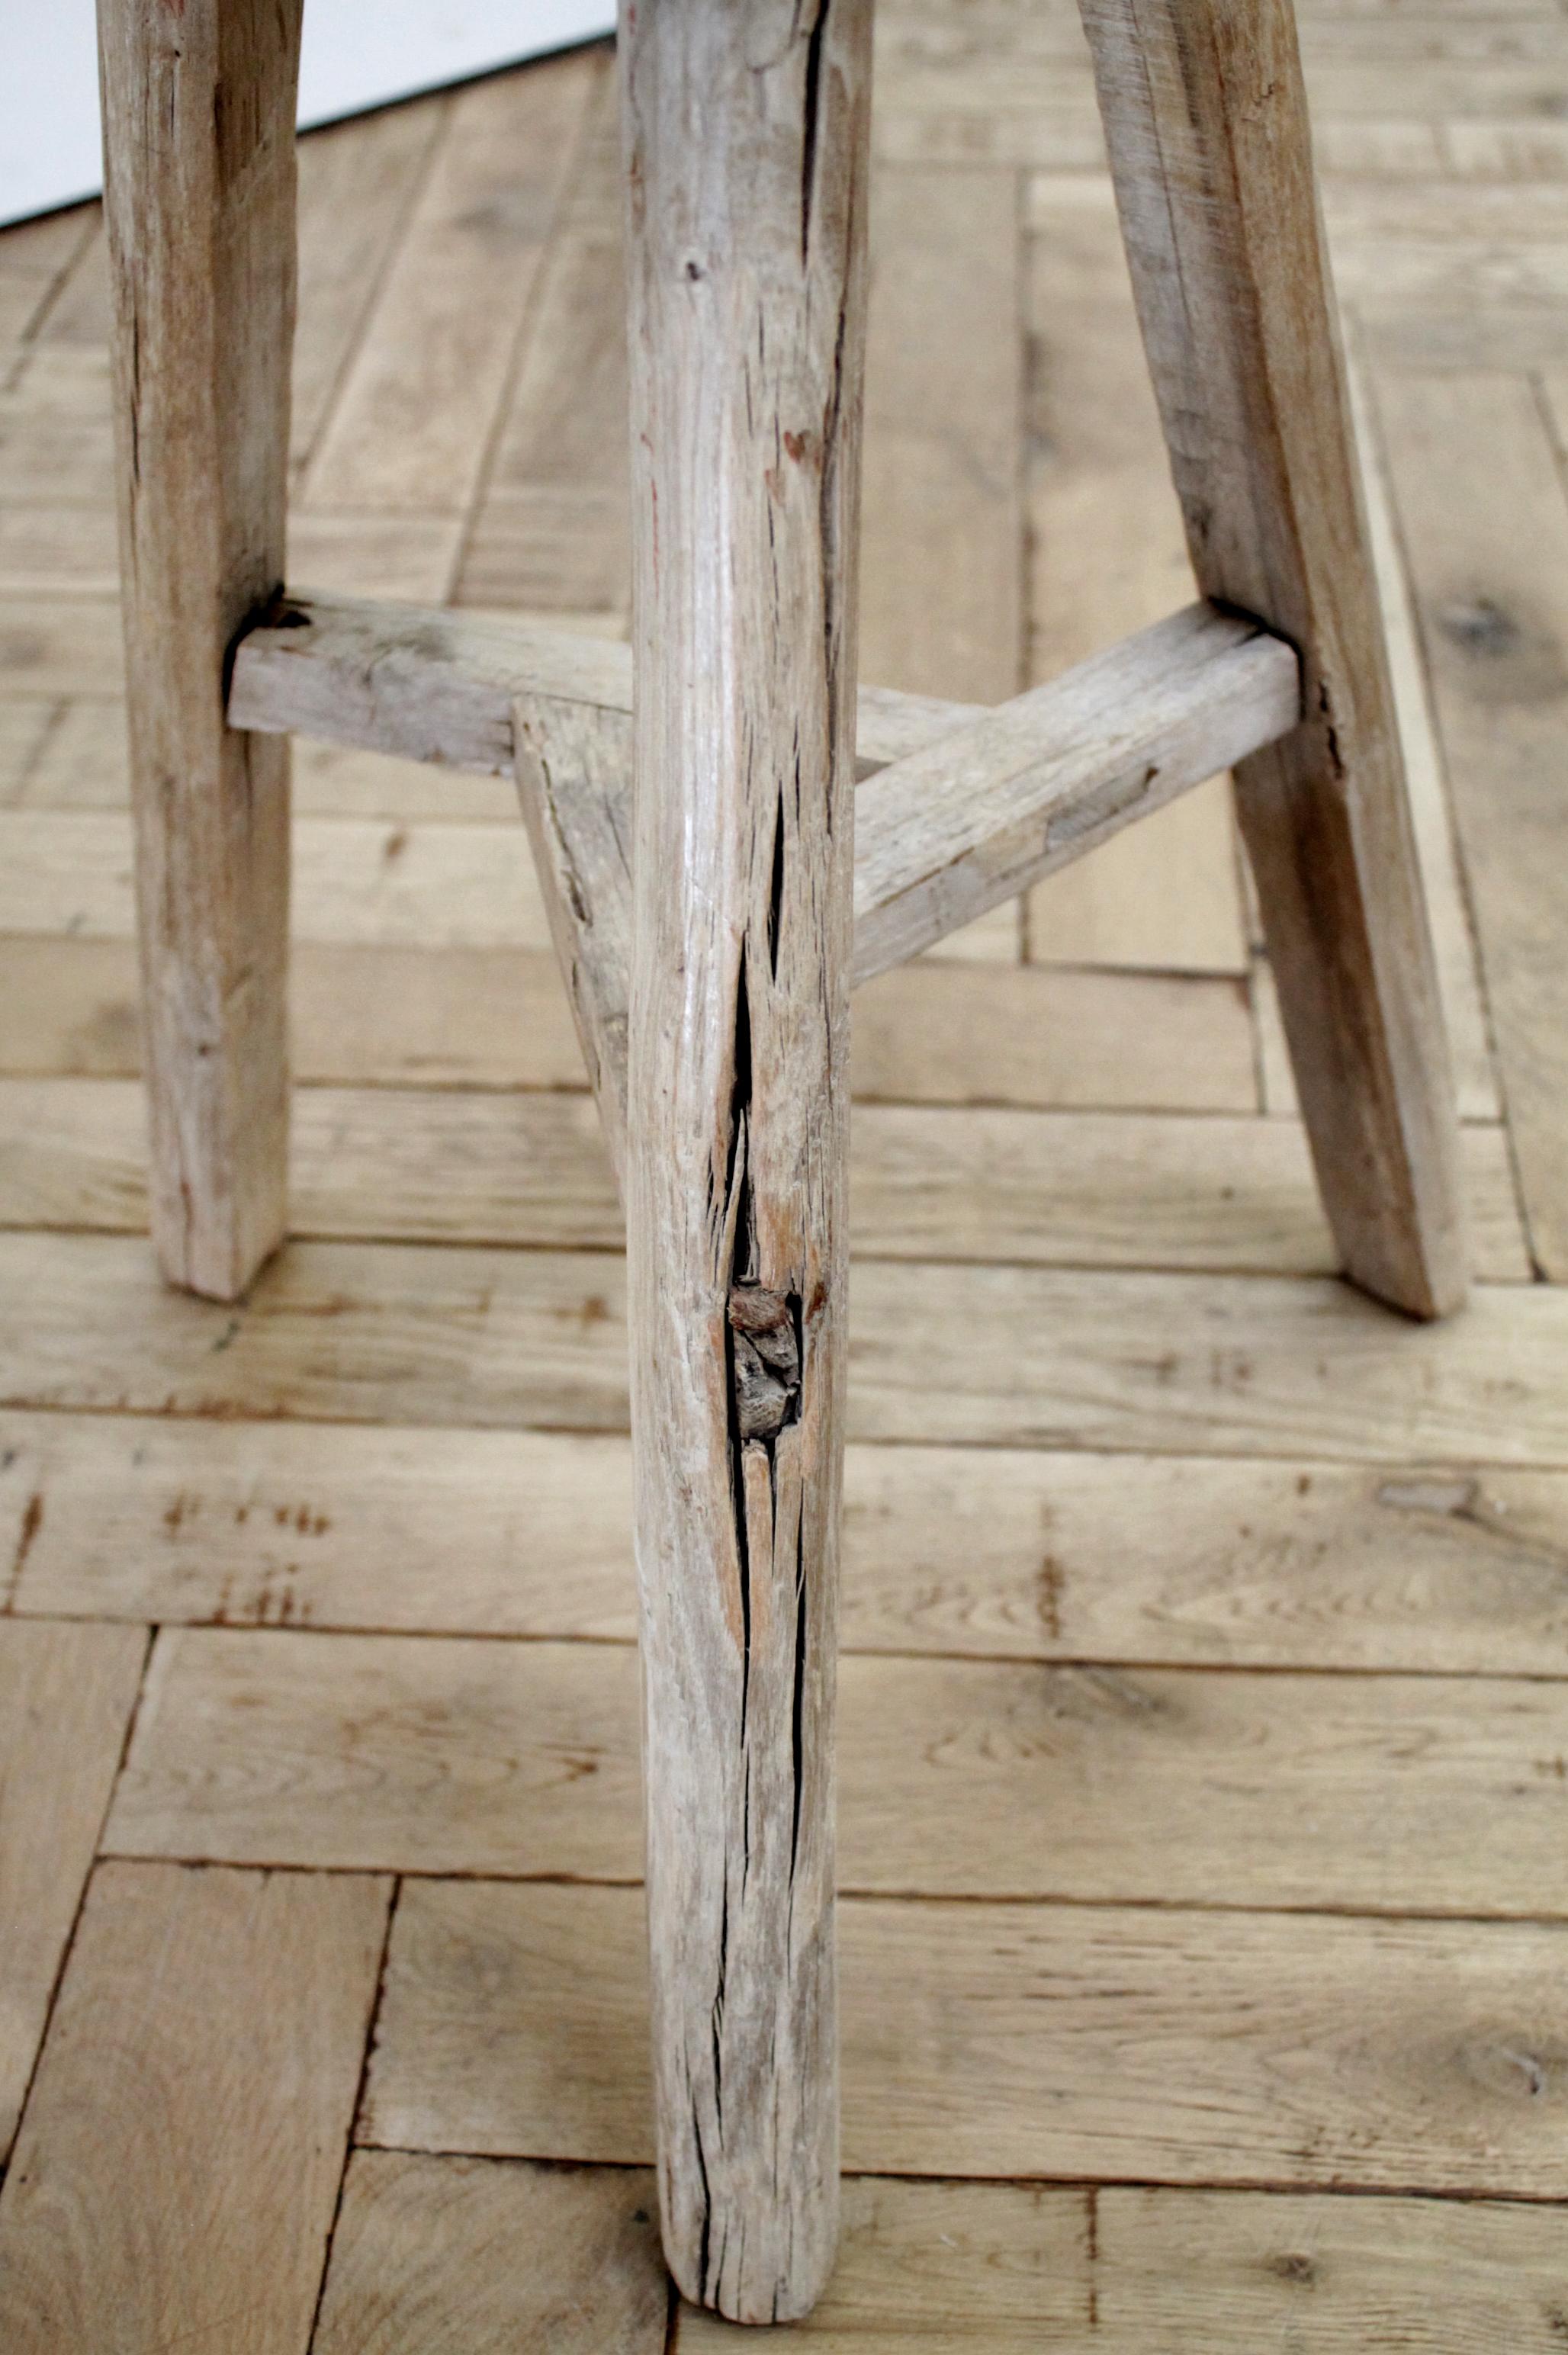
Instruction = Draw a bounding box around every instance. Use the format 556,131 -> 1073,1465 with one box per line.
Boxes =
231,598 -> 1300,1130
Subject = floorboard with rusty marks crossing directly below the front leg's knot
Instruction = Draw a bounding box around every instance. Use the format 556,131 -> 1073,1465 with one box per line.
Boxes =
18,1413 -> 1568,1677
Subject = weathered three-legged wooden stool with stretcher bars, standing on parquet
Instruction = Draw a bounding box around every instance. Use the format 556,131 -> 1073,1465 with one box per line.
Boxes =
101,0 -> 1464,2320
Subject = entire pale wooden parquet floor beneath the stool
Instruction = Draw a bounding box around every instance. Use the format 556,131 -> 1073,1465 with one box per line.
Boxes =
0,0 -> 1568,2355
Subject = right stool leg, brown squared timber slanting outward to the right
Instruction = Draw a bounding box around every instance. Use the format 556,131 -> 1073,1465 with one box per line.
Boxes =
1083,0 -> 1467,1316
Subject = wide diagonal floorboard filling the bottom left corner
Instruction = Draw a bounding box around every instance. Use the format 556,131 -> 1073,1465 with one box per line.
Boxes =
0,1865 -> 390,2355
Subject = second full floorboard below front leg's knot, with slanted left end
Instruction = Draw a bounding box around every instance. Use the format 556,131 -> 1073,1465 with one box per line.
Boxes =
104,1627 -> 1568,1922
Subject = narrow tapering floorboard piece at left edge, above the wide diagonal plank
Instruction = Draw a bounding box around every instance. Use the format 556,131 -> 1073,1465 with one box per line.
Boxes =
0,1620 -> 146,2155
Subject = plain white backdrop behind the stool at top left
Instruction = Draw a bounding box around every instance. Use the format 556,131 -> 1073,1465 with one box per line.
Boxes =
0,0 -> 615,221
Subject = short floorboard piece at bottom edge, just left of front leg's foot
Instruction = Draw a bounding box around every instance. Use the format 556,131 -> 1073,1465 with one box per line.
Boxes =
310,2150 -> 669,2355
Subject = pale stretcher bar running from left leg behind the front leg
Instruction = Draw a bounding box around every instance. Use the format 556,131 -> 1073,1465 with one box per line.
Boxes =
226,589 -> 982,777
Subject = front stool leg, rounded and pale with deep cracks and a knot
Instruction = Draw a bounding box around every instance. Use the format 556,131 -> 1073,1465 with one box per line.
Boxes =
622,0 -> 871,2322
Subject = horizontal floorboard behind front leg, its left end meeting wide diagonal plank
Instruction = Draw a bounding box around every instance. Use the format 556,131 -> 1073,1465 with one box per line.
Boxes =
362,1881 -> 1568,2199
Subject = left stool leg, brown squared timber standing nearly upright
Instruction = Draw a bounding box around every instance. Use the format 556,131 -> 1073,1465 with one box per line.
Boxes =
99,0 -> 299,1300
